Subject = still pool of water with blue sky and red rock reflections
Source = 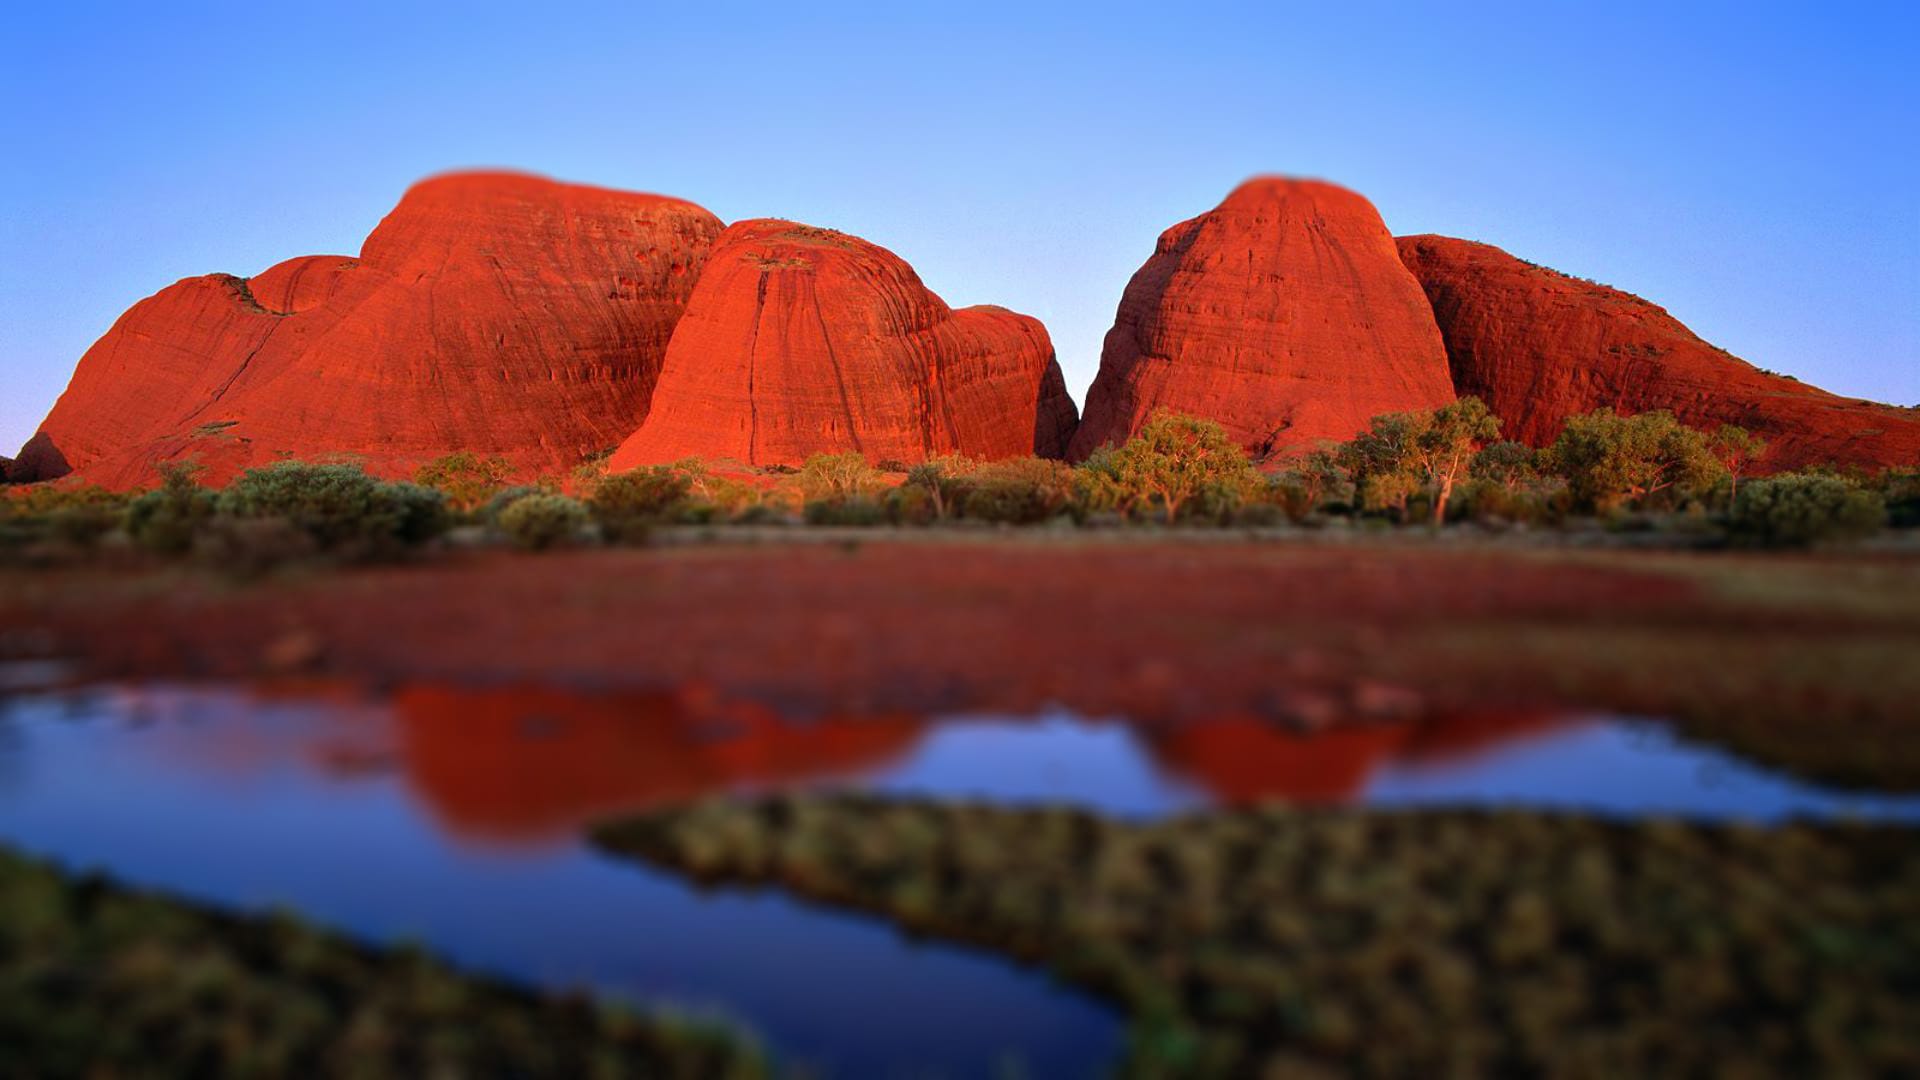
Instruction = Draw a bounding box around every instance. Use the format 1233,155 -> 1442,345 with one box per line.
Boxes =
0,686 -> 1920,1076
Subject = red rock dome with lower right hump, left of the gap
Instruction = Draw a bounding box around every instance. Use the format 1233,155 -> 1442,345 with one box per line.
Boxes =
611,221 -> 1073,469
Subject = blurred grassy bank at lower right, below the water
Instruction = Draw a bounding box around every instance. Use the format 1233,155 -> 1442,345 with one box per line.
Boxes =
595,796 -> 1920,1076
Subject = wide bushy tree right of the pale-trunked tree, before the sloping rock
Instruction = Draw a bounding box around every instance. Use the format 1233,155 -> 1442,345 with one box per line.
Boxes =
1546,409 -> 1726,511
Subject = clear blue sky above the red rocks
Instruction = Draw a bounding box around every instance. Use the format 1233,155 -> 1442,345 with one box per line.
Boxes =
0,0 -> 1920,454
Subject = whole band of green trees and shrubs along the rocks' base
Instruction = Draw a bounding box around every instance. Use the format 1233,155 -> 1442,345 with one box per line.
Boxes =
0,398 -> 1920,569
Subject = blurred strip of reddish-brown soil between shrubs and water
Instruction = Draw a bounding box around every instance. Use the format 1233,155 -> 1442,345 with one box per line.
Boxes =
0,538 -> 1920,784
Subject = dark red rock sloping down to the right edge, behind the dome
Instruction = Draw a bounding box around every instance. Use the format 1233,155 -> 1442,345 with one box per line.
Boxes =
1400,236 -> 1920,471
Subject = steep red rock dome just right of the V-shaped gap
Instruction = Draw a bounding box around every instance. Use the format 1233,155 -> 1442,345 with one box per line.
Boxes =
1071,177 -> 1453,457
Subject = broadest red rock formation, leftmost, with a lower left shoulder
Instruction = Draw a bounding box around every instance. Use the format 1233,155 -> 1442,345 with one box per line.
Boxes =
21,173 -> 720,486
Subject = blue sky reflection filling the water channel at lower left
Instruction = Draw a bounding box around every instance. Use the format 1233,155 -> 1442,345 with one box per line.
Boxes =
0,698 -> 1119,1076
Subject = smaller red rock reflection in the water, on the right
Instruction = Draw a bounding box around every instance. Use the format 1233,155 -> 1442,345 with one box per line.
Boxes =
1150,711 -> 1571,803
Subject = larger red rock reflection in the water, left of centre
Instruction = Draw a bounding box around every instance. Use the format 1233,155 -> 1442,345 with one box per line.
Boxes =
394,686 -> 925,842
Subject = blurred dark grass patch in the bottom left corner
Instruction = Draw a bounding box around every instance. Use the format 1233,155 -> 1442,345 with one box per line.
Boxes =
0,849 -> 764,1080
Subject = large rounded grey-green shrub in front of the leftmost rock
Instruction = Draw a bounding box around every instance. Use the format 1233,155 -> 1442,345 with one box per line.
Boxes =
215,461 -> 449,557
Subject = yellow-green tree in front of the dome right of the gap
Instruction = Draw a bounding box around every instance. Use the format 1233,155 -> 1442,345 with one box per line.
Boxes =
1102,409 -> 1260,525
